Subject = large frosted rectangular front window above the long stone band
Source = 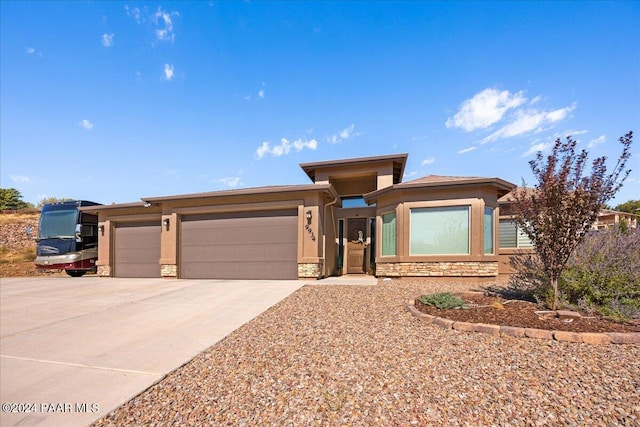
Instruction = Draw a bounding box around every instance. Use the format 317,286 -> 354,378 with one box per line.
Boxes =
410,206 -> 470,255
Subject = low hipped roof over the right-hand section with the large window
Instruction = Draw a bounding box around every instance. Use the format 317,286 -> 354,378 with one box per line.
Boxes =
365,175 -> 516,203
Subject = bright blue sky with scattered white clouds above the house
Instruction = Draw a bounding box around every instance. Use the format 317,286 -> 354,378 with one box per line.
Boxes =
0,1 -> 640,204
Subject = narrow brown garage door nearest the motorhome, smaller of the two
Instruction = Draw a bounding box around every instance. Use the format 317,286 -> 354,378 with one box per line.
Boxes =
114,220 -> 161,277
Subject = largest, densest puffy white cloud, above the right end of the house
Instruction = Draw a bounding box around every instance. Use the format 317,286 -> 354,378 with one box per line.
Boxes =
445,88 -> 527,132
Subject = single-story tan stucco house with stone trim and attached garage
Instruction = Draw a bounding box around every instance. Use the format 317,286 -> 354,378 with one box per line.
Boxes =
82,154 -> 519,279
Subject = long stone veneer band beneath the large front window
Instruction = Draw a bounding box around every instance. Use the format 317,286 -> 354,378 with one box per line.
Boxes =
376,261 -> 498,277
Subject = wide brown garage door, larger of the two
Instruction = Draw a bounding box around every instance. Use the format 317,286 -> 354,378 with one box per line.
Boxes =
180,209 -> 298,279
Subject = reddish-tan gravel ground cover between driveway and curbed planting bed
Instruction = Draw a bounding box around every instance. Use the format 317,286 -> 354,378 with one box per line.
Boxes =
95,279 -> 640,426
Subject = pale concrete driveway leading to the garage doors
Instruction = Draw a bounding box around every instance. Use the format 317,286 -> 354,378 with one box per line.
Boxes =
0,277 -> 304,426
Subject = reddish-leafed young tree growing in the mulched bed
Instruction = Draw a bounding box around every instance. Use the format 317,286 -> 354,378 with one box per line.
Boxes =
513,132 -> 633,310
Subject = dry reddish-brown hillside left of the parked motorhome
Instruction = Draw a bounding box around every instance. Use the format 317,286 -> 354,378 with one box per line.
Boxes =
0,213 -> 61,277
